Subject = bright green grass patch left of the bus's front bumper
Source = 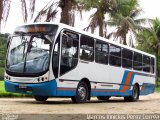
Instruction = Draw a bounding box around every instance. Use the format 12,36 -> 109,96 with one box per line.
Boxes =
0,81 -> 29,97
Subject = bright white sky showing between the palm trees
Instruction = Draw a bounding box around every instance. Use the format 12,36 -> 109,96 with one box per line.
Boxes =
2,0 -> 160,33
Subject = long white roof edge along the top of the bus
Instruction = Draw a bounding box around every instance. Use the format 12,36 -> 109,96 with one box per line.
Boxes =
15,22 -> 155,58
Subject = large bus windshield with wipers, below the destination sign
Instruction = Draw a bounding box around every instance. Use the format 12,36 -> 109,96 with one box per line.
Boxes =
6,35 -> 52,74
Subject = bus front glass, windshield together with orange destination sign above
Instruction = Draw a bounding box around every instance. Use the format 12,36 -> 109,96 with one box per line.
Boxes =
6,24 -> 58,76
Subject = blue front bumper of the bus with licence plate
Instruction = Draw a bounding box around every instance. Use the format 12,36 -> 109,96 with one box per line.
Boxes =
4,80 -> 57,96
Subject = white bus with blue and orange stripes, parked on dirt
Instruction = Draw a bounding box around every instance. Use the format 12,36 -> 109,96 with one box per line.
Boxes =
5,23 -> 156,103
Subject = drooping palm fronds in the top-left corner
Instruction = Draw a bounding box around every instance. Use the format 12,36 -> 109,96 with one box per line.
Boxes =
0,0 -> 11,33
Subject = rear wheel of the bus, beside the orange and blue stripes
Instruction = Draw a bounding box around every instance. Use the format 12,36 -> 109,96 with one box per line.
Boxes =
124,85 -> 139,102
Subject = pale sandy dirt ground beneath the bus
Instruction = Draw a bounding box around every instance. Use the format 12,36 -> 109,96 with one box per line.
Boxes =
0,93 -> 160,119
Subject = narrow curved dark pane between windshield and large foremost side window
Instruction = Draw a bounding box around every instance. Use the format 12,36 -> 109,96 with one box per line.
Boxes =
52,35 -> 60,78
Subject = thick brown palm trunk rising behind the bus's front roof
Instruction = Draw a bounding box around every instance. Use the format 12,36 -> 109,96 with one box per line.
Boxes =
60,0 -> 72,25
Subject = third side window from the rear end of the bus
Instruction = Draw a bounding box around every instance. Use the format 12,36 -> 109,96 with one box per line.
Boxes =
133,52 -> 142,71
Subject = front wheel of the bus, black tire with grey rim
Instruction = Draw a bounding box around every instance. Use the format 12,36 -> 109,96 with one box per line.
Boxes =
71,82 -> 89,103
